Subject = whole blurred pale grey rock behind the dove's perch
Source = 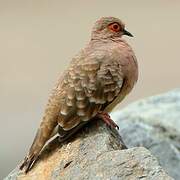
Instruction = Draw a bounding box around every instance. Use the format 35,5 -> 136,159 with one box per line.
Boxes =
111,89 -> 180,180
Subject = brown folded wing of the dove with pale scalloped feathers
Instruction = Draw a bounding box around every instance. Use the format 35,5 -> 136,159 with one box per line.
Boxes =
58,57 -> 123,130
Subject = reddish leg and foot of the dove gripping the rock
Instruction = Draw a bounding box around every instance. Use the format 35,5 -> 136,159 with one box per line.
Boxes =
96,111 -> 119,129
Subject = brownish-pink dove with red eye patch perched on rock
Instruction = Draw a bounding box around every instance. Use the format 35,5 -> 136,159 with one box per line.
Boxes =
20,17 -> 138,173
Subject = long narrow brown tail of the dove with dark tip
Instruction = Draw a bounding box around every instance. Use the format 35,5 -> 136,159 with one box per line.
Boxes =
20,118 -> 57,173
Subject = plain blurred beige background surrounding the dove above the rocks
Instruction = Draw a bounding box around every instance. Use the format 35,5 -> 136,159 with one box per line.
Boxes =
0,0 -> 180,179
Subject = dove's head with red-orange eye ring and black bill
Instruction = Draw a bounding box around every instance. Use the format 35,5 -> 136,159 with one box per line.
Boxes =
91,17 -> 133,39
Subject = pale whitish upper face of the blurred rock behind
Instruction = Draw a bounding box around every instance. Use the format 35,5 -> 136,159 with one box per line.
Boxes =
112,89 -> 180,133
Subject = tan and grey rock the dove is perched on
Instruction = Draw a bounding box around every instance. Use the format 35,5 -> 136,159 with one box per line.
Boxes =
5,121 -> 172,180
